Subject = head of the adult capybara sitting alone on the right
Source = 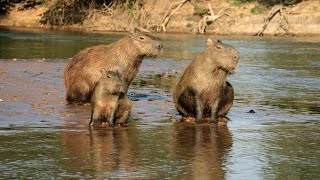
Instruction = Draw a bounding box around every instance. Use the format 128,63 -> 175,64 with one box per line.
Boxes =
204,39 -> 240,74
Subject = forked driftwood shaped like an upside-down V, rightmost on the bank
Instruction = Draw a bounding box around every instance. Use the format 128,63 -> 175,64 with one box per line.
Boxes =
255,5 -> 294,36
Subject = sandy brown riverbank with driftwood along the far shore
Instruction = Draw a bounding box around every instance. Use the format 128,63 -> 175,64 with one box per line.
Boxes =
0,0 -> 320,36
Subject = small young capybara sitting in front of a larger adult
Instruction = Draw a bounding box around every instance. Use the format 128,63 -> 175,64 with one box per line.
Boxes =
90,68 -> 131,126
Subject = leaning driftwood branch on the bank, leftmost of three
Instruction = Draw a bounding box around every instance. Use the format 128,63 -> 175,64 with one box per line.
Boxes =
153,0 -> 190,32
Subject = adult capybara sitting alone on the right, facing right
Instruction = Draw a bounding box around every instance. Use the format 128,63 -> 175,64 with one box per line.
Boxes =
172,40 -> 240,123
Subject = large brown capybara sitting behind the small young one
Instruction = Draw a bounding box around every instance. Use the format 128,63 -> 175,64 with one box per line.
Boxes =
64,29 -> 163,103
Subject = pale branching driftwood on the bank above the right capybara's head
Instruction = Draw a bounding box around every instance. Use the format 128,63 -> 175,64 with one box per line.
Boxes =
198,4 -> 229,34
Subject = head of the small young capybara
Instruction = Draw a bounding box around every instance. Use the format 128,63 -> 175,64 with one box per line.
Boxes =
99,68 -> 124,93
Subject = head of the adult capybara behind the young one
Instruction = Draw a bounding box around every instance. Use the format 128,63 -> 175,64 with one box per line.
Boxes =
129,29 -> 163,57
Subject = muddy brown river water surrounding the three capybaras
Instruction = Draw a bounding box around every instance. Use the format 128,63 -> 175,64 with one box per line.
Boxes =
0,29 -> 320,179
